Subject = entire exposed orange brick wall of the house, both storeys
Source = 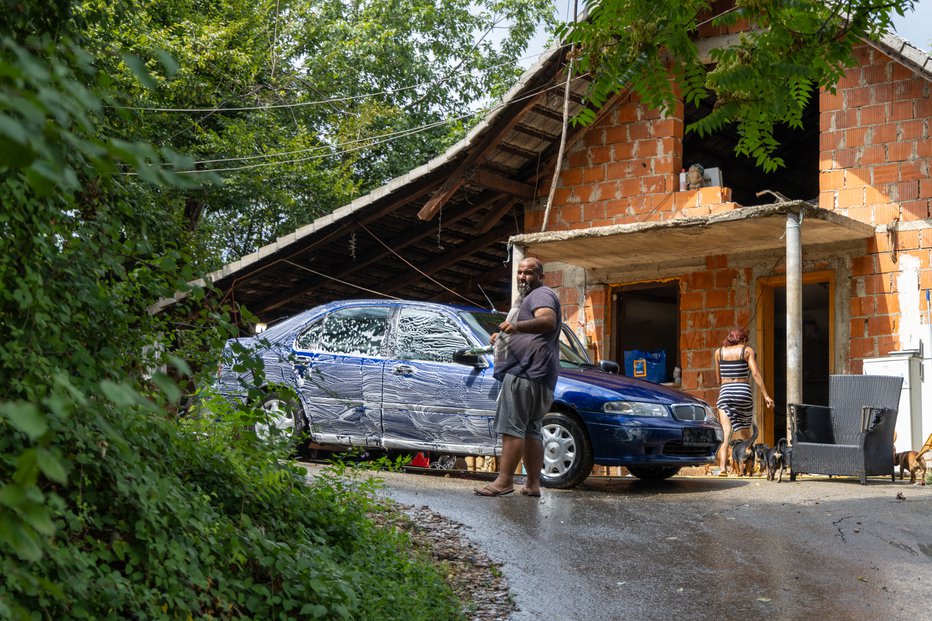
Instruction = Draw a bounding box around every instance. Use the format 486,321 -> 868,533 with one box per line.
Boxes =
525,41 -> 932,392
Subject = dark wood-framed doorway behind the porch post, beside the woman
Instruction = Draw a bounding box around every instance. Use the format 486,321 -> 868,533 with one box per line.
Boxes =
757,272 -> 835,446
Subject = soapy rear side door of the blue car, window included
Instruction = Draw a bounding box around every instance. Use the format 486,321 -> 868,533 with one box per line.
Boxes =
294,305 -> 391,446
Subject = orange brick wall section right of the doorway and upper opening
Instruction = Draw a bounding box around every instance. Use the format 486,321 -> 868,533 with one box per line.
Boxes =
819,46 -> 932,373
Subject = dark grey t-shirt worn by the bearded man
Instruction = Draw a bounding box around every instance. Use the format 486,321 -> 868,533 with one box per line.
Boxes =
494,285 -> 561,390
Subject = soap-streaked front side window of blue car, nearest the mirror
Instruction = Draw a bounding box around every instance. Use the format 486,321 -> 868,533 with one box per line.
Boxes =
395,308 -> 472,362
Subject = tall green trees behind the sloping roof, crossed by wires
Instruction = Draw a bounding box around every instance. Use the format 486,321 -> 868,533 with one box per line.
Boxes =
73,0 -> 552,269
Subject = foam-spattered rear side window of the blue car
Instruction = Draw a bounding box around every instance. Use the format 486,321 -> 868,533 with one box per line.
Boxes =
295,306 -> 390,356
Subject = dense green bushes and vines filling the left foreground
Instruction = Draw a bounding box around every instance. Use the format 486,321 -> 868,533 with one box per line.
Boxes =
0,22 -> 460,621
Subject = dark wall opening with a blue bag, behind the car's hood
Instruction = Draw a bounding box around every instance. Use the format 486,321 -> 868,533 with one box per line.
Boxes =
612,280 -> 680,383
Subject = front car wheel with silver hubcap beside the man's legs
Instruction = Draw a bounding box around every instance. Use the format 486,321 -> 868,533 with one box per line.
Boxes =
541,412 -> 592,489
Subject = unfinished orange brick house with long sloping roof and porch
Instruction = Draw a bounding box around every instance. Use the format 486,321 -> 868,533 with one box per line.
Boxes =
184,7 -> 932,450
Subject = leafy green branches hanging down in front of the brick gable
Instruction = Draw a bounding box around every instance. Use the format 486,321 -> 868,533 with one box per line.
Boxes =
558,0 -> 915,172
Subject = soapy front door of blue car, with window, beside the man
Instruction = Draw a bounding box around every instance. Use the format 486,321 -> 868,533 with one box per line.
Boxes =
382,306 -> 498,455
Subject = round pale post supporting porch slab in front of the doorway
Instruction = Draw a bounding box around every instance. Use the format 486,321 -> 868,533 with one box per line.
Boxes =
786,211 -> 803,442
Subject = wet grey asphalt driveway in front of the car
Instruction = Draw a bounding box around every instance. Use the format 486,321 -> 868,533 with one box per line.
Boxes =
328,473 -> 932,621
